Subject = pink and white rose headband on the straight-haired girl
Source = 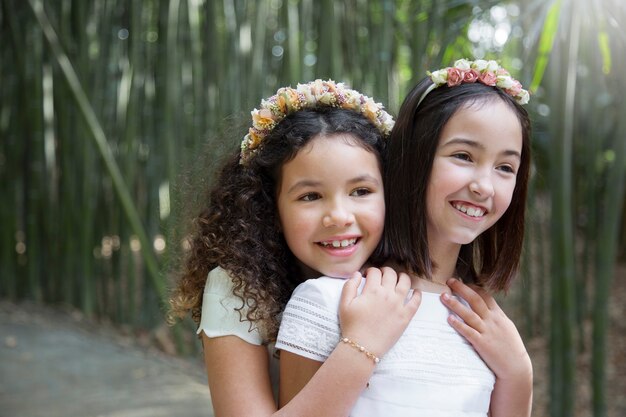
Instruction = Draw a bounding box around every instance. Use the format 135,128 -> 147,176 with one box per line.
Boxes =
417,59 -> 530,106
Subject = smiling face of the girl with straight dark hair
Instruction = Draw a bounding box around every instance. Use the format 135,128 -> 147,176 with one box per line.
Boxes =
427,99 -> 522,251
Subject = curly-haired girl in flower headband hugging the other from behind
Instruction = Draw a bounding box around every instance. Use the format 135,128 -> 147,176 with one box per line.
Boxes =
169,80 -> 420,417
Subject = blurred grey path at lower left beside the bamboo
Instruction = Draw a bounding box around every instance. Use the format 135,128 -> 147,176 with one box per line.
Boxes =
0,301 -> 212,417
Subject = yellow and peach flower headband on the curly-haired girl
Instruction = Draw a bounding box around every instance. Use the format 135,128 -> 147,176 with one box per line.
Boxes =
240,79 -> 394,165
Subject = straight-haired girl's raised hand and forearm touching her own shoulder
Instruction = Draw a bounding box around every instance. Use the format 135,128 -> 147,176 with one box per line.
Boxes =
442,279 -> 533,417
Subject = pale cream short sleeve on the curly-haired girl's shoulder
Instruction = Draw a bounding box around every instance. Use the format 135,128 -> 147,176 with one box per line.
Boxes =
197,267 -> 265,345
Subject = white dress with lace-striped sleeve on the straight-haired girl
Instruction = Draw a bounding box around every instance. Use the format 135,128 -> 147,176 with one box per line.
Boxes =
276,277 -> 495,417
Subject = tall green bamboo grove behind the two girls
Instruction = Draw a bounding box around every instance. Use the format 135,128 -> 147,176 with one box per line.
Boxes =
0,0 -> 626,417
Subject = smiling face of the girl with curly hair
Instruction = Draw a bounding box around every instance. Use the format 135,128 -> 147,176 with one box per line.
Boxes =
277,134 -> 385,278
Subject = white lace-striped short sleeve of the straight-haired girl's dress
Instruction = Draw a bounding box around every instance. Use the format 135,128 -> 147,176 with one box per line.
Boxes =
276,277 -> 345,362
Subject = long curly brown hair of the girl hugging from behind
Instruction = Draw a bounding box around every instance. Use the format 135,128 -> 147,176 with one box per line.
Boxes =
168,108 -> 385,340
